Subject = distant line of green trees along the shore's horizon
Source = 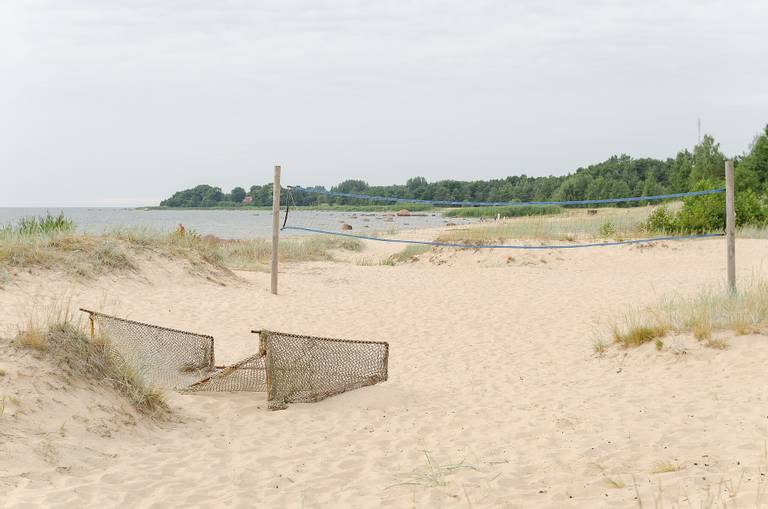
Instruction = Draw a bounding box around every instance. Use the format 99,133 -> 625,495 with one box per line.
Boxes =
160,126 -> 768,207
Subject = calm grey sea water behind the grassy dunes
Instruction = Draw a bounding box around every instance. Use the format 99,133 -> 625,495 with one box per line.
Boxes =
0,208 -> 468,239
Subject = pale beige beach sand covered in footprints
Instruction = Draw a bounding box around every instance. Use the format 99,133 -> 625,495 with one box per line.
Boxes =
0,239 -> 768,508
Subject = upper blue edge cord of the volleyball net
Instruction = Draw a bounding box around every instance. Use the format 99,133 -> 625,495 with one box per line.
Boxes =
289,186 -> 725,207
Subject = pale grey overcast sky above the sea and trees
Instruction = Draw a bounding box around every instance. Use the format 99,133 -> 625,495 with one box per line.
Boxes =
0,0 -> 768,206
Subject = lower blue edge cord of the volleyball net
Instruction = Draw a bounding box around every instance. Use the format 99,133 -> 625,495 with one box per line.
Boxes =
283,226 -> 725,249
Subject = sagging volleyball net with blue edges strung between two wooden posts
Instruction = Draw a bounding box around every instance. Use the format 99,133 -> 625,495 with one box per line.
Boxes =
281,186 -> 725,250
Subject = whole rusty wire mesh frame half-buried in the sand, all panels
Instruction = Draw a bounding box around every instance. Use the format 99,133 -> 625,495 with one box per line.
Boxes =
82,309 -> 389,410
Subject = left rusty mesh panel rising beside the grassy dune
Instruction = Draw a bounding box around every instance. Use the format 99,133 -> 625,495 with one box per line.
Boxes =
81,309 -> 214,389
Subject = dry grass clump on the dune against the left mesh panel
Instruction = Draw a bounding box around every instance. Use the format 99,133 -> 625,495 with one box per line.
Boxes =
13,315 -> 170,418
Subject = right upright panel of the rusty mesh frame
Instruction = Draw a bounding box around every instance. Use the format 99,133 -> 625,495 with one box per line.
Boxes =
254,331 -> 389,409
